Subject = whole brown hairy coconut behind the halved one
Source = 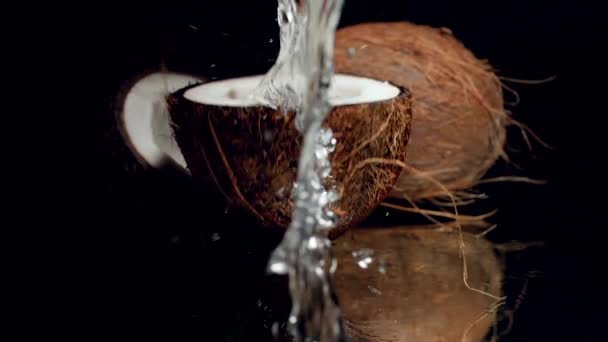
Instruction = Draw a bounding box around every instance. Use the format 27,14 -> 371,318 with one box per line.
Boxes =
335,22 -> 507,200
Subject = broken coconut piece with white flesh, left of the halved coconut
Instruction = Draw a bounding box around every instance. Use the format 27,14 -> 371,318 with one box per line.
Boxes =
118,72 -> 201,171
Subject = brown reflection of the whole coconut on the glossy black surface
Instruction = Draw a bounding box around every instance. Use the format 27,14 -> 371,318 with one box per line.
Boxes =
334,227 -> 502,342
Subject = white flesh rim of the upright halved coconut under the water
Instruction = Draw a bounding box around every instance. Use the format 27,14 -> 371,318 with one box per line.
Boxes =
184,74 -> 400,107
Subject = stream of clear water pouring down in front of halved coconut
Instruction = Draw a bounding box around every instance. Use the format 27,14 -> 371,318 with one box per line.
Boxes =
254,0 -> 344,342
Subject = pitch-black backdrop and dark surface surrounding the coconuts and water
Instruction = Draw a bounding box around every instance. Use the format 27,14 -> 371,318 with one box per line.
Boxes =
21,0 -> 607,341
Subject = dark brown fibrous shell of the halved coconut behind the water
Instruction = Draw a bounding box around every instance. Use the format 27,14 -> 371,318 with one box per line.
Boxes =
168,83 -> 412,237
